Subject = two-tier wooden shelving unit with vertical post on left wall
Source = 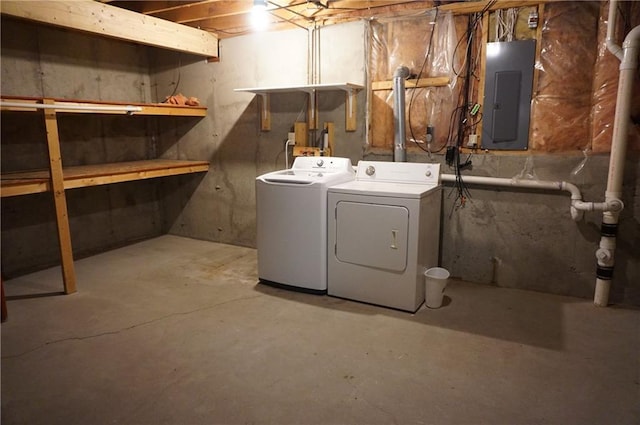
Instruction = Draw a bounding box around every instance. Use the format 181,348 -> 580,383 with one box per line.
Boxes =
0,96 -> 209,294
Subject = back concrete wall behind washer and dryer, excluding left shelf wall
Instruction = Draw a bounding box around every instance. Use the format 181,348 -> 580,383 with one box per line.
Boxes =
152,19 -> 640,304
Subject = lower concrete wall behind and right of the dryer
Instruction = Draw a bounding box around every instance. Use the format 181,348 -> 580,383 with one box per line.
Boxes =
365,153 -> 640,305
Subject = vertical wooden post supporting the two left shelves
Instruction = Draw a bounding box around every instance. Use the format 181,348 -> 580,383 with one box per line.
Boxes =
42,99 -> 76,294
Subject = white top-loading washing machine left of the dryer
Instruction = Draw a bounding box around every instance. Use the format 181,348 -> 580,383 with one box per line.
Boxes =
256,157 -> 355,294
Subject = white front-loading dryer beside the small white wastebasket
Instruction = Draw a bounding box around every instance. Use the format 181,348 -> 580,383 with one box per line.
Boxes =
327,161 -> 442,312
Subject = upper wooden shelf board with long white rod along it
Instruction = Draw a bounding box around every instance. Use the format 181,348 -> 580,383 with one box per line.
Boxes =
1,96 -> 207,117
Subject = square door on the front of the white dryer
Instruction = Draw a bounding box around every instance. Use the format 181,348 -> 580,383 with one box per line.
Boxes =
335,201 -> 409,272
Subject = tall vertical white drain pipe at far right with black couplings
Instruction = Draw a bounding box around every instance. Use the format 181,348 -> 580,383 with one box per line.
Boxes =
593,0 -> 640,307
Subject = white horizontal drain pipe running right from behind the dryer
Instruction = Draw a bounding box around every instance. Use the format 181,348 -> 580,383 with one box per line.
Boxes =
440,174 -> 623,221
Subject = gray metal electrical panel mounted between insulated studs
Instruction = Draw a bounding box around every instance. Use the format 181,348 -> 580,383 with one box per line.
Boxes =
481,40 -> 536,150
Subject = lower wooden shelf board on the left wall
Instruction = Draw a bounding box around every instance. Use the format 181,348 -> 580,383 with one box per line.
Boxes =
1,159 -> 209,198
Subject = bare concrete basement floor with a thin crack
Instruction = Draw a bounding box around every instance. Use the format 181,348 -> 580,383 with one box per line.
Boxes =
2,236 -> 640,425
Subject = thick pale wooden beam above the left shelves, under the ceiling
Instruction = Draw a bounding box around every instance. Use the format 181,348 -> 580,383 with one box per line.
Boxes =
2,0 -> 218,57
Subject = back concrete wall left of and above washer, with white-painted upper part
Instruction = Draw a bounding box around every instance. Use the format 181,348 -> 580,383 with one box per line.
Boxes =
151,22 -> 366,247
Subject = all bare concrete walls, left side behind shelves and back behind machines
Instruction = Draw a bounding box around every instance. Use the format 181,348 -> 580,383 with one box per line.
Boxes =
2,16 -> 640,305
